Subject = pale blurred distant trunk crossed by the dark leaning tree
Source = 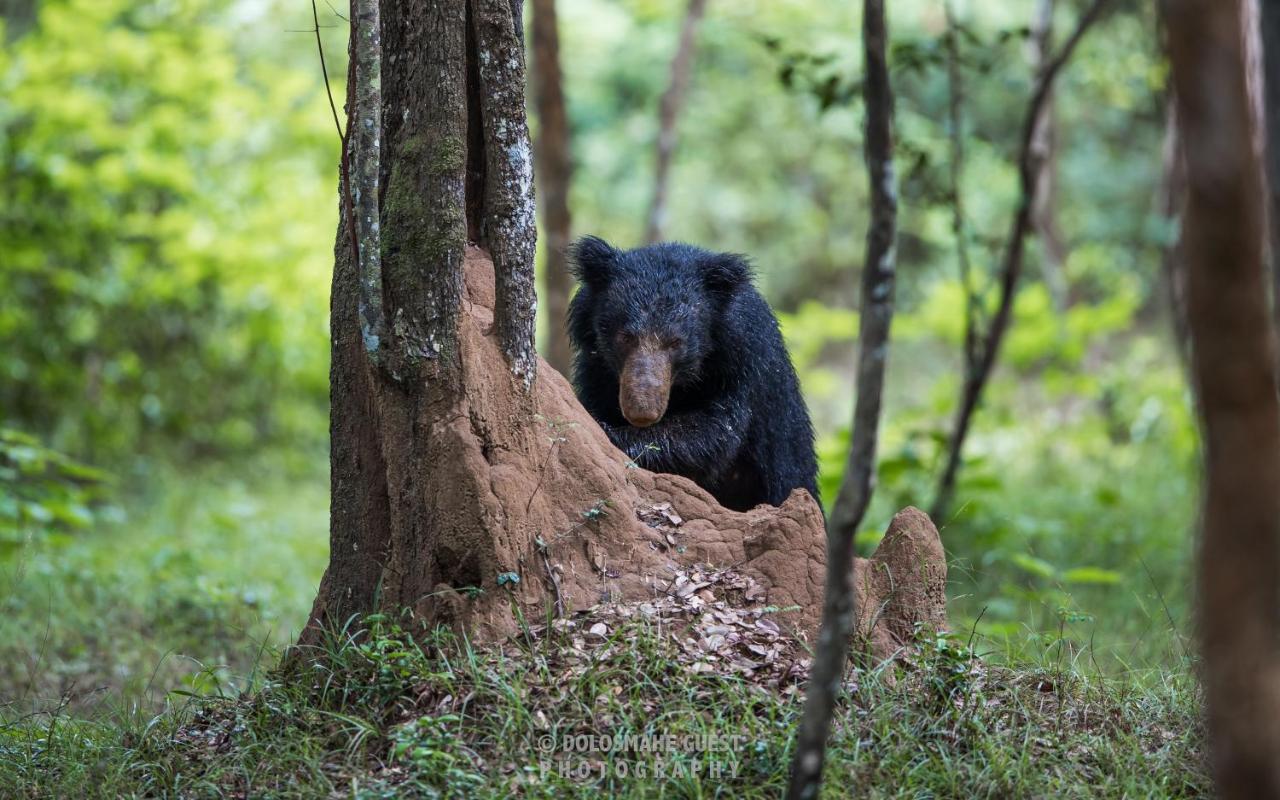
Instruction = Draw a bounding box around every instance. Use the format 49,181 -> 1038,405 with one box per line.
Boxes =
1030,0 -> 1071,311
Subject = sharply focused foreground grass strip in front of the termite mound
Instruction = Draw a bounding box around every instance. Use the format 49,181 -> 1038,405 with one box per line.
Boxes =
0,609 -> 1210,797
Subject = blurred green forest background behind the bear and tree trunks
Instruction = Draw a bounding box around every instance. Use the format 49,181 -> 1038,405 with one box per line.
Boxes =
0,0 -> 1198,713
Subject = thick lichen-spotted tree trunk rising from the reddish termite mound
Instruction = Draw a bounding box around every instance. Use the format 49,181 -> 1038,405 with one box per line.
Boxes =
302,0 -> 535,644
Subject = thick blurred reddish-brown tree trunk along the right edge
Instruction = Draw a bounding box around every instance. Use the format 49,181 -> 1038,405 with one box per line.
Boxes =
1164,0 -> 1280,797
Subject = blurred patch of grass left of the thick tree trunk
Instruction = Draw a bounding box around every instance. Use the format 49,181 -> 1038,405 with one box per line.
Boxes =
0,461 -> 328,717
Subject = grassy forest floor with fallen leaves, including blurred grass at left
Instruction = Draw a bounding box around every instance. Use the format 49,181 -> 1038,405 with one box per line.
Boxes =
0,458 -> 1210,797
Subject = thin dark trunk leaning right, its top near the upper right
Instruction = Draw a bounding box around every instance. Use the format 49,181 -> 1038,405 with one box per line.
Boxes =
929,0 -> 1110,520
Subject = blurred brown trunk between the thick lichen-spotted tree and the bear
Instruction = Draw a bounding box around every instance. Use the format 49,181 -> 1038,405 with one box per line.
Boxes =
532,0 -> 573,375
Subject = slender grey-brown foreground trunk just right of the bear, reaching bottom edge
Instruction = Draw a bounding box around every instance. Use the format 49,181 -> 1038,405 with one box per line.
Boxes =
787,0 -> 897,800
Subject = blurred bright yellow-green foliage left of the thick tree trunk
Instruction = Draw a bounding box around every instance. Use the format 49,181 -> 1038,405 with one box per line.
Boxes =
0,0 -> 335,461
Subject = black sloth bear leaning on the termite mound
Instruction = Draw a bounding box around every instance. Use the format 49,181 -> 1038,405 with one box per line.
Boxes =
568,237 -> 818,511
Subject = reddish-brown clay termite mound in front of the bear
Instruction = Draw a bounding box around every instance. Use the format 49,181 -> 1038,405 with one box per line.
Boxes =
317,248 -> 946,658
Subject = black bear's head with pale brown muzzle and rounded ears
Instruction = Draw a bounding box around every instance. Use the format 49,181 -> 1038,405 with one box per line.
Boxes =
570,237 -> 751,428
